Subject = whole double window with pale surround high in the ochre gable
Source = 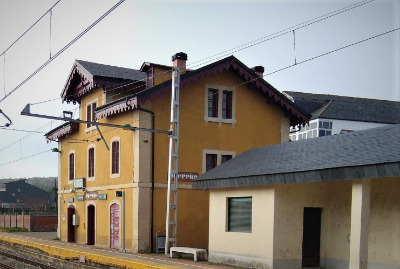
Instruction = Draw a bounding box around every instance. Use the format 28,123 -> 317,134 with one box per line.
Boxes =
204,85 -> 236,125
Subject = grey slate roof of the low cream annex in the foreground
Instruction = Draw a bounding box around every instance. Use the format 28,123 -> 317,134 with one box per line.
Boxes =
193,124 -> 400,189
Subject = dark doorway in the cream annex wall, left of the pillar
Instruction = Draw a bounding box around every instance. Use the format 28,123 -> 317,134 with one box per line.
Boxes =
302,207 -> 322,267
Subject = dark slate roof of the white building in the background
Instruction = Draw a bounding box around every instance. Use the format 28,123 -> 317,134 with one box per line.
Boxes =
283,91 -> 400,124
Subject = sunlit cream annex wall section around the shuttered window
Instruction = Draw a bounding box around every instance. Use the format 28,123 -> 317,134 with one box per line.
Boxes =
209,187 -> 274,268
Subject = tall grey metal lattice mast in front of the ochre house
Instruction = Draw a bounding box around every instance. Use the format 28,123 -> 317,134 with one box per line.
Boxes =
165,67 -> 180,253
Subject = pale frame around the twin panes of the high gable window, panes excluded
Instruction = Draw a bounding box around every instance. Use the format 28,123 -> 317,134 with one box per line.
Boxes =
204,84 -> 236,126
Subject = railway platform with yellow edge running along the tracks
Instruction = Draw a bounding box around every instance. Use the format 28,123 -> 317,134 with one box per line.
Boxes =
0,232 -> 232,269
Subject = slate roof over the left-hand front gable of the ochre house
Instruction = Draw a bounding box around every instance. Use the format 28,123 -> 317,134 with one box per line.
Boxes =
76,60 -> 146,80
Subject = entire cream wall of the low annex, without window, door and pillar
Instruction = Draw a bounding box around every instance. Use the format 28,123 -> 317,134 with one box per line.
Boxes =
209,178 -> 400,269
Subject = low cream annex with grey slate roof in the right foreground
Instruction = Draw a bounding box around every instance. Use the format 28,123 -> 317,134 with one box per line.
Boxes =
193,124 -> 400,269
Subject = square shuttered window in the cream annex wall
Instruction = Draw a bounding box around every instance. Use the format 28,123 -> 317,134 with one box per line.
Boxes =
227,197 -> 253,233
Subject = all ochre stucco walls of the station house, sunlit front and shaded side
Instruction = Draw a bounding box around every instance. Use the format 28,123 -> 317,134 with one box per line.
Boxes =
59,67 -> 289,251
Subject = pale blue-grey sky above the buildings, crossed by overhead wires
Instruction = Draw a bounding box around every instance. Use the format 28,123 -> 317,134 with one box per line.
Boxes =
0,0 -> 400,178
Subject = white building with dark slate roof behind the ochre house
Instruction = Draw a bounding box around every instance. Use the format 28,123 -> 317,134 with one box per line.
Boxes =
283,91 -> 400,141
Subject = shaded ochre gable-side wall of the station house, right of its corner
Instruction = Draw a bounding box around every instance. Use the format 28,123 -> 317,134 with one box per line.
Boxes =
147,68 -> 289,248
